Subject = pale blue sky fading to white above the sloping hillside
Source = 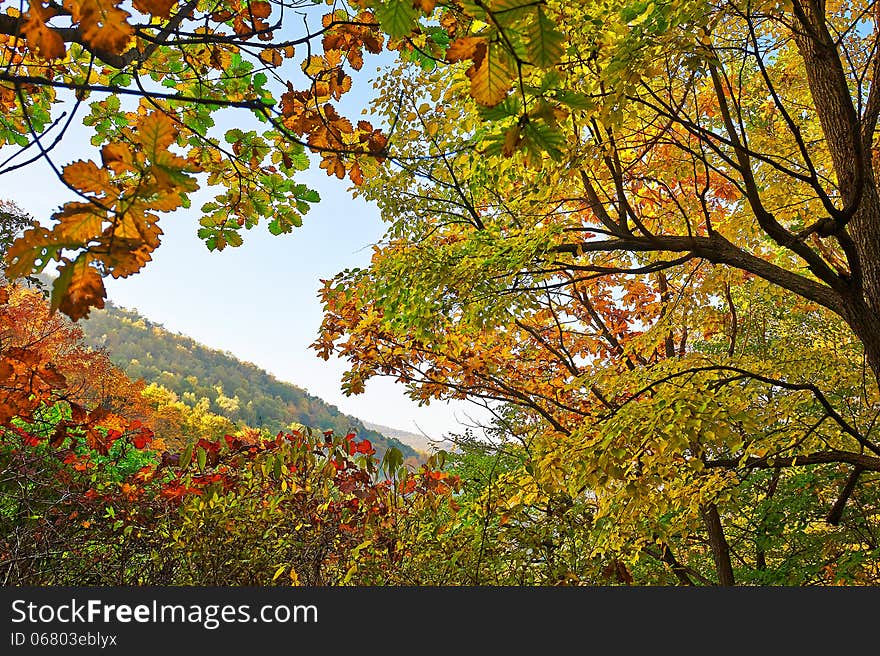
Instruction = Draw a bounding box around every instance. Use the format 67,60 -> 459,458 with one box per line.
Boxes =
0,69 -> 496,439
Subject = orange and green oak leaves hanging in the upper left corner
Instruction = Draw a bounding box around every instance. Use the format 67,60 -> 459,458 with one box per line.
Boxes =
0,0 -> 402,318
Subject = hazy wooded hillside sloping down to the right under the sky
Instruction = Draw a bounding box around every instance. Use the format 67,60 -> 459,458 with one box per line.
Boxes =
79,302 -> 423,460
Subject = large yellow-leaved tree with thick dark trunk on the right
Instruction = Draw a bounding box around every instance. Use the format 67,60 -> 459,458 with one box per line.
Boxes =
316,0 -> 880,584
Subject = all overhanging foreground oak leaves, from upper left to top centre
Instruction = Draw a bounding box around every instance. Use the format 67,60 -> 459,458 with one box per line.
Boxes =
0,0 -> 576,320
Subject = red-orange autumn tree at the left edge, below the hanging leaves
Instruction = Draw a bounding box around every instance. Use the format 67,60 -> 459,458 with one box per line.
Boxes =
0,284 -> 161,584
